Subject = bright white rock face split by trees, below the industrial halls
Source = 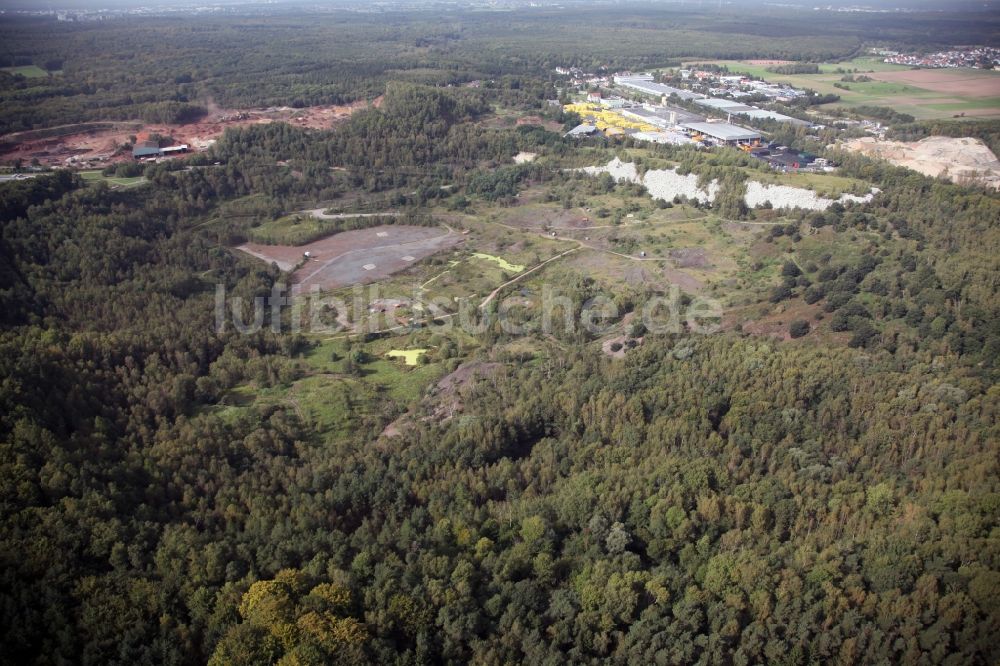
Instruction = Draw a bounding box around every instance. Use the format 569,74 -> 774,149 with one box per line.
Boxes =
579,157 -> 879,210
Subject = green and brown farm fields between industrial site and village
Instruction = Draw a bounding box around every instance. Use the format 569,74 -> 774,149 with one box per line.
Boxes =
688,58 -> 1000,120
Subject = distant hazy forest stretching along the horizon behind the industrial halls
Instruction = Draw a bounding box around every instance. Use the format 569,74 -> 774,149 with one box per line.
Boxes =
0,5 -> 998,134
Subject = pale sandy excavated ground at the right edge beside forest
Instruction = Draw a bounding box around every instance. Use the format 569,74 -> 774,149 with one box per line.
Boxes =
844,136 -> 1000,189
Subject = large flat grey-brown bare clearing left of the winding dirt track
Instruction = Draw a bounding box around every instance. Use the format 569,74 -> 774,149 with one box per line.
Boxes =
237,225 -> 462,289
